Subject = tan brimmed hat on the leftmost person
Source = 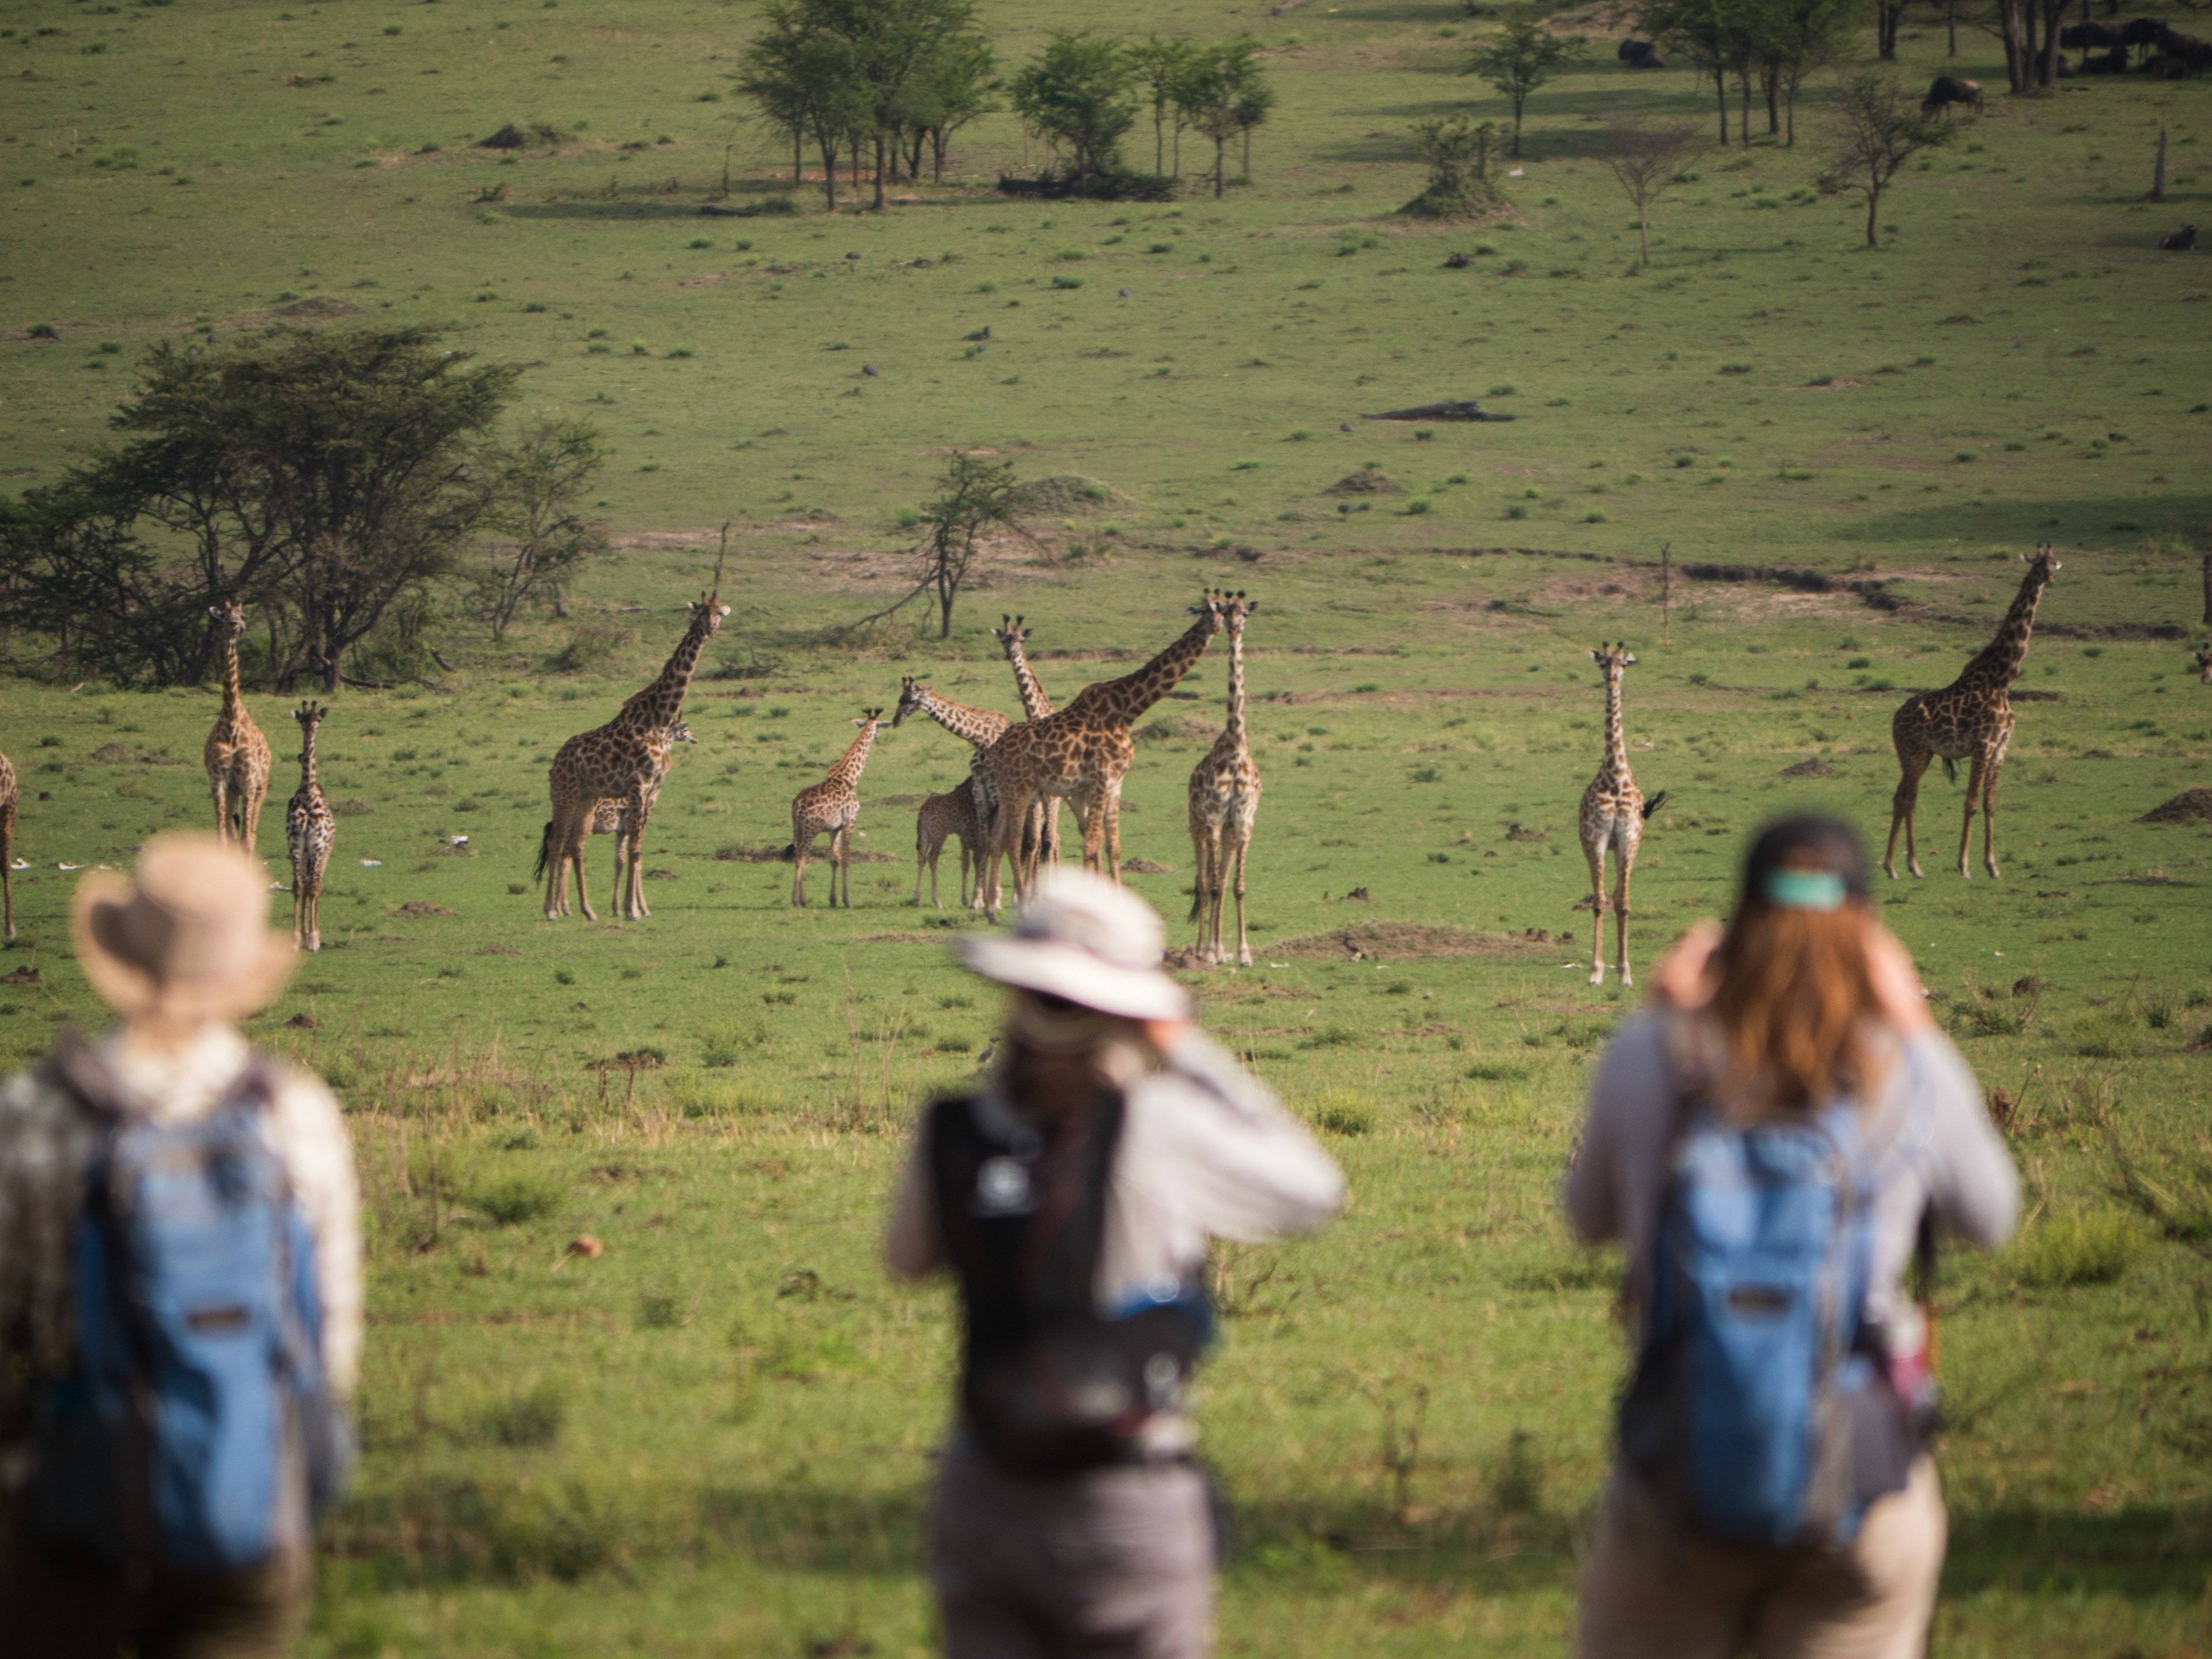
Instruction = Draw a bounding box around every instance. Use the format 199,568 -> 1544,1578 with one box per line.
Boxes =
71,834 -> 298,1020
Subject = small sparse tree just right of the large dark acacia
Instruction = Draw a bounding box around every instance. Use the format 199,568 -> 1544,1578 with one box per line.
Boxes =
474,421 -> 606,639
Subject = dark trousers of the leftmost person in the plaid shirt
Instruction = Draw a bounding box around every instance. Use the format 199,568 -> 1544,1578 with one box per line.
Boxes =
0,1528 -> 314,1659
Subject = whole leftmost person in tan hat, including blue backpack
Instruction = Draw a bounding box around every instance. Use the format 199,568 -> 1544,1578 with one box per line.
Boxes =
0,834 -> 361,1659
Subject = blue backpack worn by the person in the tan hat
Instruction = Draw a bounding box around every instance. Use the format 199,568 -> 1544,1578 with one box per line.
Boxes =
33,1044 -> 350,1570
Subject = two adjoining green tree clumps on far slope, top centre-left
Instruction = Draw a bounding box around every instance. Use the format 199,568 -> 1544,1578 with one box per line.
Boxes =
737,0 -> 1274,213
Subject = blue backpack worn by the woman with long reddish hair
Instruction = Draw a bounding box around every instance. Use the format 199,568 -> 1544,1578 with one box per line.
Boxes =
1619,1101 -> 1920,1546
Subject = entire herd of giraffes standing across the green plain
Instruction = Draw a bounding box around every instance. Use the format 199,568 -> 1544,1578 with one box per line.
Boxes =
0,546 -> 2212,984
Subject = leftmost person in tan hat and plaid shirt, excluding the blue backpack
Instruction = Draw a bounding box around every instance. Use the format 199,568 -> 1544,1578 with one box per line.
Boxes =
0,834 -> 361,1659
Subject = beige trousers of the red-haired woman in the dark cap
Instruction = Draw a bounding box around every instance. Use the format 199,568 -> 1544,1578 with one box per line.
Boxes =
1575,1458 -> 1944,1659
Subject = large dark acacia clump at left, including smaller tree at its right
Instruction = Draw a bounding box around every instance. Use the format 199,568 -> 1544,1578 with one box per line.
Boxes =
0,327 -> 604,690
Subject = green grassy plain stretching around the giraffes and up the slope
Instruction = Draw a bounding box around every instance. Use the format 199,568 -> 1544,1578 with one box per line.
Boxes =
0,0 -> 2212,1659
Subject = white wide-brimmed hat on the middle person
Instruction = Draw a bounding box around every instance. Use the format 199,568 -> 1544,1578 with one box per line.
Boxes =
953,869 -> 1190,1020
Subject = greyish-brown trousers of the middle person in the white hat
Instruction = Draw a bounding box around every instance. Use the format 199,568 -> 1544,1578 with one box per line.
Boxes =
929,1435 -> 1214,1659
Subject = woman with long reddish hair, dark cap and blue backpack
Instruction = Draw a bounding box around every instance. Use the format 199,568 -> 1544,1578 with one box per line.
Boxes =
1566,816 -> 2020,1659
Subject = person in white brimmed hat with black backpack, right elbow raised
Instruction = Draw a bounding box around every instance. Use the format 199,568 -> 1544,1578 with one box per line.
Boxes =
885,869 -> 1345,1659
